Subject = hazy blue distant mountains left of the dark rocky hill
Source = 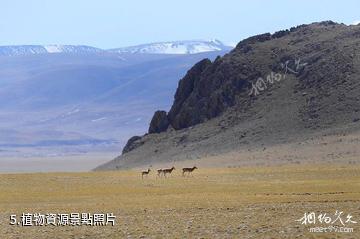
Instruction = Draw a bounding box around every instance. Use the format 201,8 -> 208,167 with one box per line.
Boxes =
0,41 -> 233,157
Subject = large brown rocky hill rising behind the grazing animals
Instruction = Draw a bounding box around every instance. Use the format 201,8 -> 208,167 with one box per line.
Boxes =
96,21 -> 360,170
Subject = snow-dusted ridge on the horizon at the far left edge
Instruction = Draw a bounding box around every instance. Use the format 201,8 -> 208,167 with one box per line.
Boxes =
0,45 -> 103,56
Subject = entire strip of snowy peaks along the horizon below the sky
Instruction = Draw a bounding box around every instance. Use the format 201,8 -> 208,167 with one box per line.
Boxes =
0,40 -> 232,56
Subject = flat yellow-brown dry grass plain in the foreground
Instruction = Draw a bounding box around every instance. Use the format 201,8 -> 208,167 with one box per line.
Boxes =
0,164 -> 360,239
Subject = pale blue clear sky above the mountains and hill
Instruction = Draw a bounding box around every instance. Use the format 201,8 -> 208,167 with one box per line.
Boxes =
0,0 -> 360,49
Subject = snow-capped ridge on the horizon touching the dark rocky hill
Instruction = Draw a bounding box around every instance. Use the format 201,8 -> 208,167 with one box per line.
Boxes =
110,40 -> 232,54
